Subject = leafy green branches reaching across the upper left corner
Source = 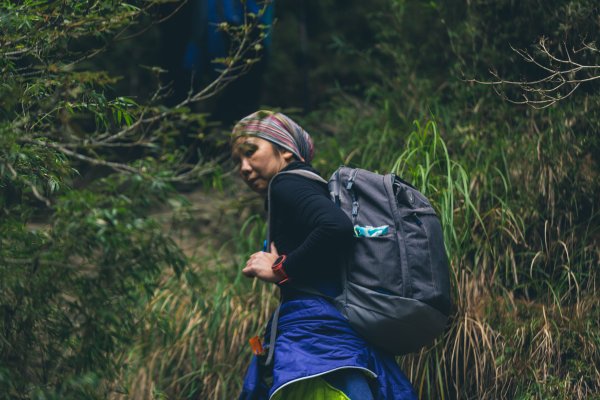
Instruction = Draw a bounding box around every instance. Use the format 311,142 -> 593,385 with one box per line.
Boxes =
0,0 -> 267,195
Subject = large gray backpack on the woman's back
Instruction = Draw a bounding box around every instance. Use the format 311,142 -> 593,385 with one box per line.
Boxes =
272,167 -> 450,355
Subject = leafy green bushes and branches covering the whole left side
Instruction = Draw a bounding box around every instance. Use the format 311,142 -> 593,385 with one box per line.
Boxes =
0,0 -> 259,399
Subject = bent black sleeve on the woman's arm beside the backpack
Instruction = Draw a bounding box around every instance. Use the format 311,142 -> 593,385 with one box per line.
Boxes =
271,175 -> 353,280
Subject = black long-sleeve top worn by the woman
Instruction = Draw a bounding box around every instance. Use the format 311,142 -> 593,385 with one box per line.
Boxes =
267,162 -> 353,296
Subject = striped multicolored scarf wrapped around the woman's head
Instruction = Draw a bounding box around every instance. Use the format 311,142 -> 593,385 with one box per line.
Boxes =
232,110 -> 314,164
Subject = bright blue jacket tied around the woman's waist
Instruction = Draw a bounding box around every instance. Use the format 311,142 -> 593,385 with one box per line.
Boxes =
240,295 -> 417,400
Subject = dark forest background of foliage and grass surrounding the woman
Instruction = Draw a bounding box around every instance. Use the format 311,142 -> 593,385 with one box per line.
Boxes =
0,0 -> 600,400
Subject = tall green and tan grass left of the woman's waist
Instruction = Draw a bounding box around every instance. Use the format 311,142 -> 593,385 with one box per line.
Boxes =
114,205 -> 276,400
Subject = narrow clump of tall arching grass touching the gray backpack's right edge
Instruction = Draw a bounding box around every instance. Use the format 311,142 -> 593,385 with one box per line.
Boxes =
382,121 -> 506,398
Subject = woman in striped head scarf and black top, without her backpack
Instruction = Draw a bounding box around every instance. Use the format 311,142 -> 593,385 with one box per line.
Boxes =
232,111 -> 416,400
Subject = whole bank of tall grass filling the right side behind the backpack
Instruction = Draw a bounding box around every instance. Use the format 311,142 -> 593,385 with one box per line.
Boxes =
312,106 -> 600,399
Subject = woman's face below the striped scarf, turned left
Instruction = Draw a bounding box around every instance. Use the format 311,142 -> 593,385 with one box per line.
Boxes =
232,136 -> 293,194
